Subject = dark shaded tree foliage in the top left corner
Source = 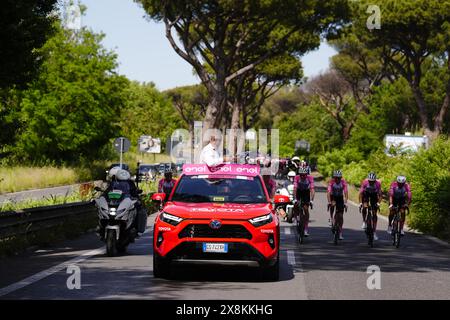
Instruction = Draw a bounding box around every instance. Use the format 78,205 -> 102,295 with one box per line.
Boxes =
0,0 -> 57,89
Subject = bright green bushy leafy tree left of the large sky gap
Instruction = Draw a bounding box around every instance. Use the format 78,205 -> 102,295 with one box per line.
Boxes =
16,23 -> 128,162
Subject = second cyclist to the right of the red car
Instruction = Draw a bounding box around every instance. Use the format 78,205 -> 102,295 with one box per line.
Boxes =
327,170 -> 348,240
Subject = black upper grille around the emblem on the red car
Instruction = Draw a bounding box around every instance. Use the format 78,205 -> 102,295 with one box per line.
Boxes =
178,224 -> 252,240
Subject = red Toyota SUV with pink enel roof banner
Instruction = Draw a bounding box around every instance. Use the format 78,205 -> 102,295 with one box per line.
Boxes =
153,164 -> 280,280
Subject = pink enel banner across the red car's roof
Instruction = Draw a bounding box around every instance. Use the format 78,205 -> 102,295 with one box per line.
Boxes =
183,163 -> 259,177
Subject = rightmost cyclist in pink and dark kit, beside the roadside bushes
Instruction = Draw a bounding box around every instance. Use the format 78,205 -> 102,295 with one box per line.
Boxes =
388,176 -> 412,235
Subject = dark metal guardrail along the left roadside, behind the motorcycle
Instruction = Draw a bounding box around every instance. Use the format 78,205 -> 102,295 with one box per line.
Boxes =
0,202 -> 97,240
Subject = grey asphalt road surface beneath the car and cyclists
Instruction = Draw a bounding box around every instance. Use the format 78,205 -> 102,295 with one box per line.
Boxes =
0,184 -> 450,300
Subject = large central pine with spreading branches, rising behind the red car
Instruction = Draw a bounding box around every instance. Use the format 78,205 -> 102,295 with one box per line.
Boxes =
136,0 -> 348,129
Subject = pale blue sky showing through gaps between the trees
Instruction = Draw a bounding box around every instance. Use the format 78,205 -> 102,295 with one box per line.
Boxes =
75,0 -> 335,90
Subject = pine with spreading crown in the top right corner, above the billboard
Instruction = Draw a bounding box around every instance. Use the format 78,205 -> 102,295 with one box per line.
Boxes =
352,0 -> 450,137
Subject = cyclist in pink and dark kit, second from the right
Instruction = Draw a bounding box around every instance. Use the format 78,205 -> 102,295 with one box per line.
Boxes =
359,172 -> 382,240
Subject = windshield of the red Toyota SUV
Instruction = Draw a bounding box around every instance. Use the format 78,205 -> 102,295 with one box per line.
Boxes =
171,176 -> 267,204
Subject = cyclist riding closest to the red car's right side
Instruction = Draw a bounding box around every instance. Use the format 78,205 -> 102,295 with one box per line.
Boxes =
294,167 -> 315,237
